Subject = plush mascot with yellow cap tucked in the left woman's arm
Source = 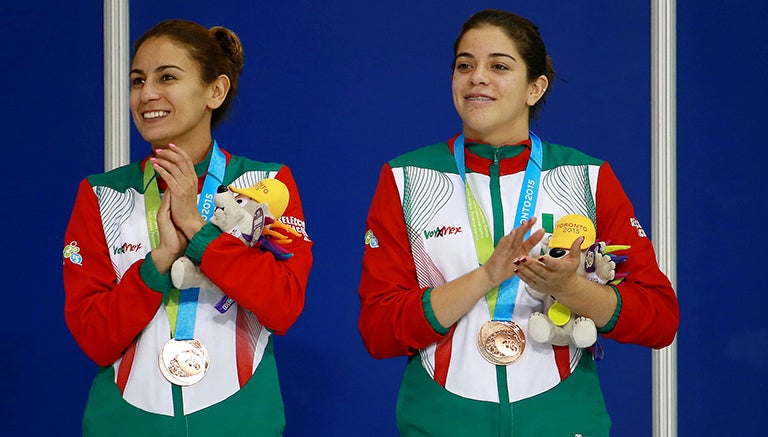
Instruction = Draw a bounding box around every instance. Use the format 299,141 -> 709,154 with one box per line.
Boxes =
171,178 -> 301,296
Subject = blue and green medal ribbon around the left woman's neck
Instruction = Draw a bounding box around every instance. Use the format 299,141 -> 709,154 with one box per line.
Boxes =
144,140 -> 227,340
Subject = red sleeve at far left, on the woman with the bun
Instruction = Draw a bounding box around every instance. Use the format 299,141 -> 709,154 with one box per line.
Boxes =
63,180 -> 162,366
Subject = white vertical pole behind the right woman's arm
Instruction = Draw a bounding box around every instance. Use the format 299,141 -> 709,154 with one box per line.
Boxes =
651,0 -> 677,437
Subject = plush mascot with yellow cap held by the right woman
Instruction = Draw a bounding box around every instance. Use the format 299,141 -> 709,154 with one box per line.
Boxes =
526,214 -> 629,348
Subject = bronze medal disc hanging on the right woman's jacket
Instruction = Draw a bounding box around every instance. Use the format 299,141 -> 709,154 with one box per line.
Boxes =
477,320 -> 525,366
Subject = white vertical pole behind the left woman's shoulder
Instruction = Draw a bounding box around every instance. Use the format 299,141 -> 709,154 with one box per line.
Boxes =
104,0 -> 131,171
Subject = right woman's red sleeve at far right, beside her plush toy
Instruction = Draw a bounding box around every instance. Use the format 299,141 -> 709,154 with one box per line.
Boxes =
596,163 -> 680,349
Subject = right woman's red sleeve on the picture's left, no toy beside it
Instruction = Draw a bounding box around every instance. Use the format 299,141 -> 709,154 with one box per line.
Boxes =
358,165 -> 441,358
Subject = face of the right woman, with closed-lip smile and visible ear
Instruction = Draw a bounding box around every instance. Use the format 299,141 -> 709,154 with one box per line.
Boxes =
451,25 -> 548,145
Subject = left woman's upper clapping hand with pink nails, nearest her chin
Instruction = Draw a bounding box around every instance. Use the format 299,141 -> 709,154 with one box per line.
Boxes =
152,144 -> 205,239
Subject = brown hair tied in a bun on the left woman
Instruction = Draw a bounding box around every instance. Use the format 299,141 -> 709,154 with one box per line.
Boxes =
133,19 -> 245,128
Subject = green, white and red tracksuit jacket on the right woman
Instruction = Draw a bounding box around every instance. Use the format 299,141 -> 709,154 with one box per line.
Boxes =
359,137 -> 679,436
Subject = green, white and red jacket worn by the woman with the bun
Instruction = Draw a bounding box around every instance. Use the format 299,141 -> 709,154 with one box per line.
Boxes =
63,144 -> 312,432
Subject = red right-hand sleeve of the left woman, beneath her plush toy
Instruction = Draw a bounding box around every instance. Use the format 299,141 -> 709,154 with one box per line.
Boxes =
200,166 -> 312,335
